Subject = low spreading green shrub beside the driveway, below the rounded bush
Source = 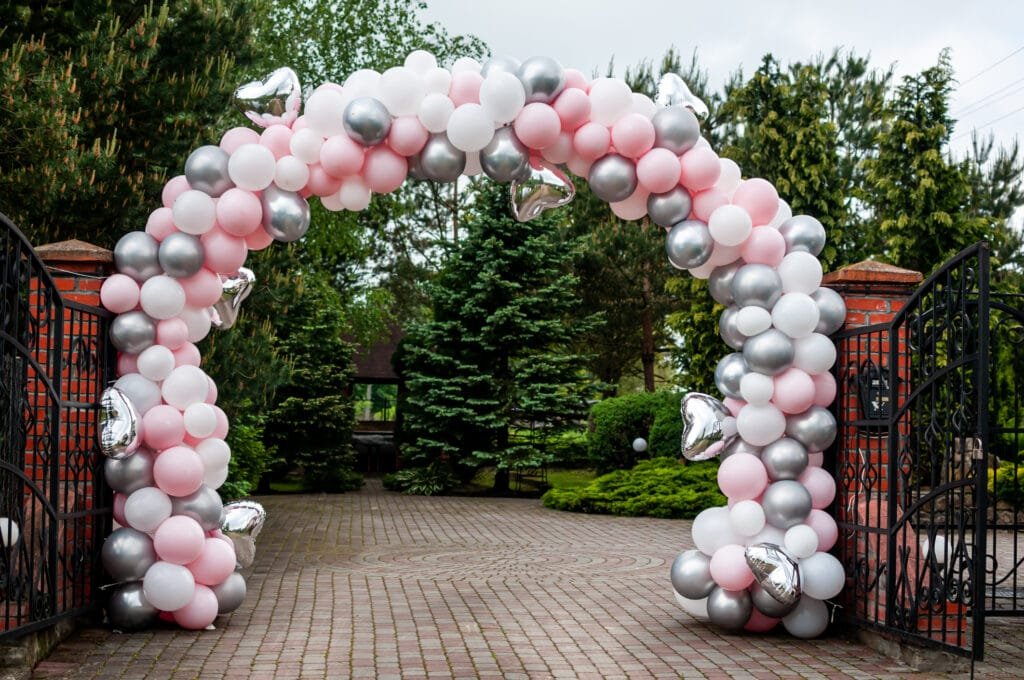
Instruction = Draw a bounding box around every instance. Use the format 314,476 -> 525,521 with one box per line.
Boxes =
542,458 -> 725,519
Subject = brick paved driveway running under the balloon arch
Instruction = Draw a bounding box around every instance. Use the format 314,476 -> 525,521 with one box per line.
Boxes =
34,481 -> 1024,679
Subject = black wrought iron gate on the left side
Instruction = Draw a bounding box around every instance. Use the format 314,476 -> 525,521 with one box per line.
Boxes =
0,215 -> 112,638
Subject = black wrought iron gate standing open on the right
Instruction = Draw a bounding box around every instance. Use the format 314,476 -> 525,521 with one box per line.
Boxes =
836,244 -> 1024,658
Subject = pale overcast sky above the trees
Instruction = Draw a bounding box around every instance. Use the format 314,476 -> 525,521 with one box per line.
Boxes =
424,0 -> 1024,159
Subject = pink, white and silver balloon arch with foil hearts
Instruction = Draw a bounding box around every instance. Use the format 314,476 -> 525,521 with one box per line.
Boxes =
100,51 -> 845,637
